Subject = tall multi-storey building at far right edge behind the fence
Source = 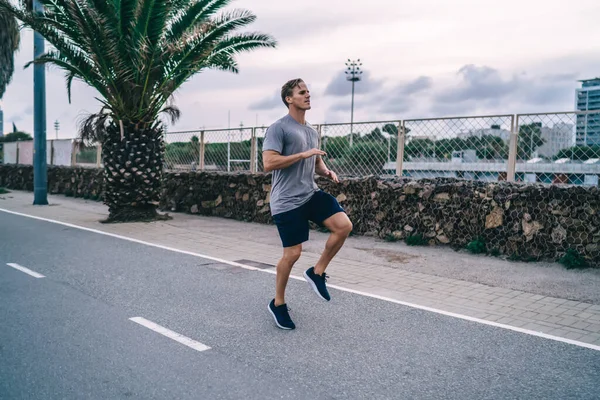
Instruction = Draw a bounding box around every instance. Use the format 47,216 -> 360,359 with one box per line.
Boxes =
575,78 -> 600,146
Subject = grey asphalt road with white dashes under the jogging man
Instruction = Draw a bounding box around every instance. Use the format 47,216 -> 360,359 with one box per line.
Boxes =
0,212 -> 600,400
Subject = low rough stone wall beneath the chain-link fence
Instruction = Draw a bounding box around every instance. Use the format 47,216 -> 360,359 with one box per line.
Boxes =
0,166 -> 600,266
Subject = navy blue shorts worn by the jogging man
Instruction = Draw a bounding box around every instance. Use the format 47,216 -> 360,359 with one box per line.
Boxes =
273,190 -> 344,247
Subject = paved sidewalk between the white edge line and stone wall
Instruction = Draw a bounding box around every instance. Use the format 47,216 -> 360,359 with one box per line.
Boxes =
0,191 -> 600,345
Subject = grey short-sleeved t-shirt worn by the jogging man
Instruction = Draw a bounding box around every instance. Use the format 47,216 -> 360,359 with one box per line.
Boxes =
263,114 -> 319,215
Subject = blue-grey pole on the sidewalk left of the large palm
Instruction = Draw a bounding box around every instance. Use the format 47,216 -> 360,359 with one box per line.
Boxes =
33,0 -> 48,205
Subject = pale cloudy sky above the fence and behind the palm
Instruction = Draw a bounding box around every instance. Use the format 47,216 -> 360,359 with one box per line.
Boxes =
1,0 -> 600,138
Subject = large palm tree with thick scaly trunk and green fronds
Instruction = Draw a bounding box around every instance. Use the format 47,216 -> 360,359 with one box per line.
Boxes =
0,0 -> 276,222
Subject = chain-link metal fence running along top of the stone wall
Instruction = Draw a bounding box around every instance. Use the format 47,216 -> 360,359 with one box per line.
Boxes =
3,110 -> 600,186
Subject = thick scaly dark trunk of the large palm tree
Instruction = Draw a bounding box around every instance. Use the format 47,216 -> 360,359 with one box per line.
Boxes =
102,123 -> 164,222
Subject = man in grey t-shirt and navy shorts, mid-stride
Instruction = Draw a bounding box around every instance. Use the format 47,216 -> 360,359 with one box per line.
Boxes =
263,79 -> 352,329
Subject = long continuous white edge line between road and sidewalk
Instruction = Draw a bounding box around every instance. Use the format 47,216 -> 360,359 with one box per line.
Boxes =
0,208 -> 600,351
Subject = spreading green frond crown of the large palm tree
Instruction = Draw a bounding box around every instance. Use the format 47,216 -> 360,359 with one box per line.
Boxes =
0,0 -> 276,135
